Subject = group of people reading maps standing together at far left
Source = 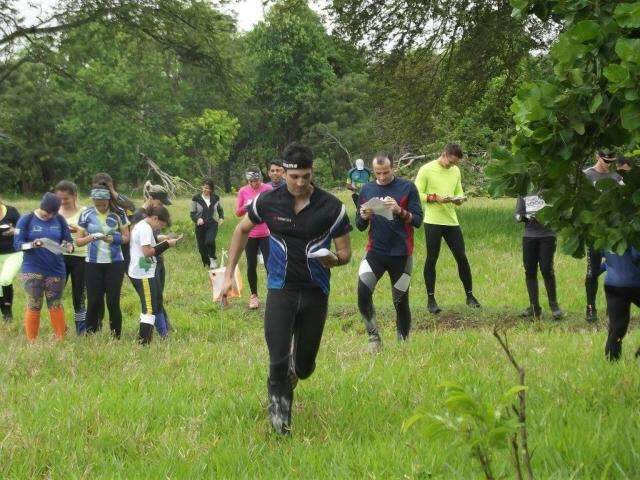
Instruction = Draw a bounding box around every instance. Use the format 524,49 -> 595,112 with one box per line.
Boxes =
0,173 -> 178,343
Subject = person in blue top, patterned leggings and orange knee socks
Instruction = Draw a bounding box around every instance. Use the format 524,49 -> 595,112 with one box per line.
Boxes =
13,193 -> 73,341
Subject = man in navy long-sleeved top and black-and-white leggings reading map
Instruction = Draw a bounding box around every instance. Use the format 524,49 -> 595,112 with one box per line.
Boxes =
356,153 -> 422,353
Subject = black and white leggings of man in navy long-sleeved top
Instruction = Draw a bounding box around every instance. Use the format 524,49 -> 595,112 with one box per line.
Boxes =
358,252 -> 413,339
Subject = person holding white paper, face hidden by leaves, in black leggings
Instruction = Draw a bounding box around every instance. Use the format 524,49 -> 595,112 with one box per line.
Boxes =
515,195 -> 564,320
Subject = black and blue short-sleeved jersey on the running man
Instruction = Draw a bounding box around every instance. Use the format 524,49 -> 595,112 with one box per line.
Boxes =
247,187 -> 351,294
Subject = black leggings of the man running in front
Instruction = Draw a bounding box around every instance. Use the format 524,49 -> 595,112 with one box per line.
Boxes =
264,288 -> 329,394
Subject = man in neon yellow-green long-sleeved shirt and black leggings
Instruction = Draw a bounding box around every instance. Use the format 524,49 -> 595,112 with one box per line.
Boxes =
416,143 -> 480,313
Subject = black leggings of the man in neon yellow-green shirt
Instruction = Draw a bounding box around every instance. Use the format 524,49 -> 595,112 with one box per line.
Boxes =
424,223 -> 473,295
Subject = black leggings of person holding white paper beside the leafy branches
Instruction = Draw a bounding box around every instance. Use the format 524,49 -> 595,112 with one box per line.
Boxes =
522,237 -> 557,310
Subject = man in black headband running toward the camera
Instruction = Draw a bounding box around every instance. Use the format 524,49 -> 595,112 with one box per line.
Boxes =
222,143 -> 351,434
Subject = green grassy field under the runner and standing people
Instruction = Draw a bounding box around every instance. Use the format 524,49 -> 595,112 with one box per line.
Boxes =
0,193 -> 640,479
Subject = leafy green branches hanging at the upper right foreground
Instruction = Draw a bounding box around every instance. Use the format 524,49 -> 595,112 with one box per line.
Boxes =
487,0 -> 640,256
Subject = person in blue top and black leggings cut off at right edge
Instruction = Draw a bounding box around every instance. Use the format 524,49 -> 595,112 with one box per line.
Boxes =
604,247 -> 640,361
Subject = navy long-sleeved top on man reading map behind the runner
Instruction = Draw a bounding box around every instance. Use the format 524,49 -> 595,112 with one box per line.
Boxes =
356,177 -> 423,257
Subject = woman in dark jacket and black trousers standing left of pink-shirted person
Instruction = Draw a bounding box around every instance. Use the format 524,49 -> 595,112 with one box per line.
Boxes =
190,178 -> 224,269
